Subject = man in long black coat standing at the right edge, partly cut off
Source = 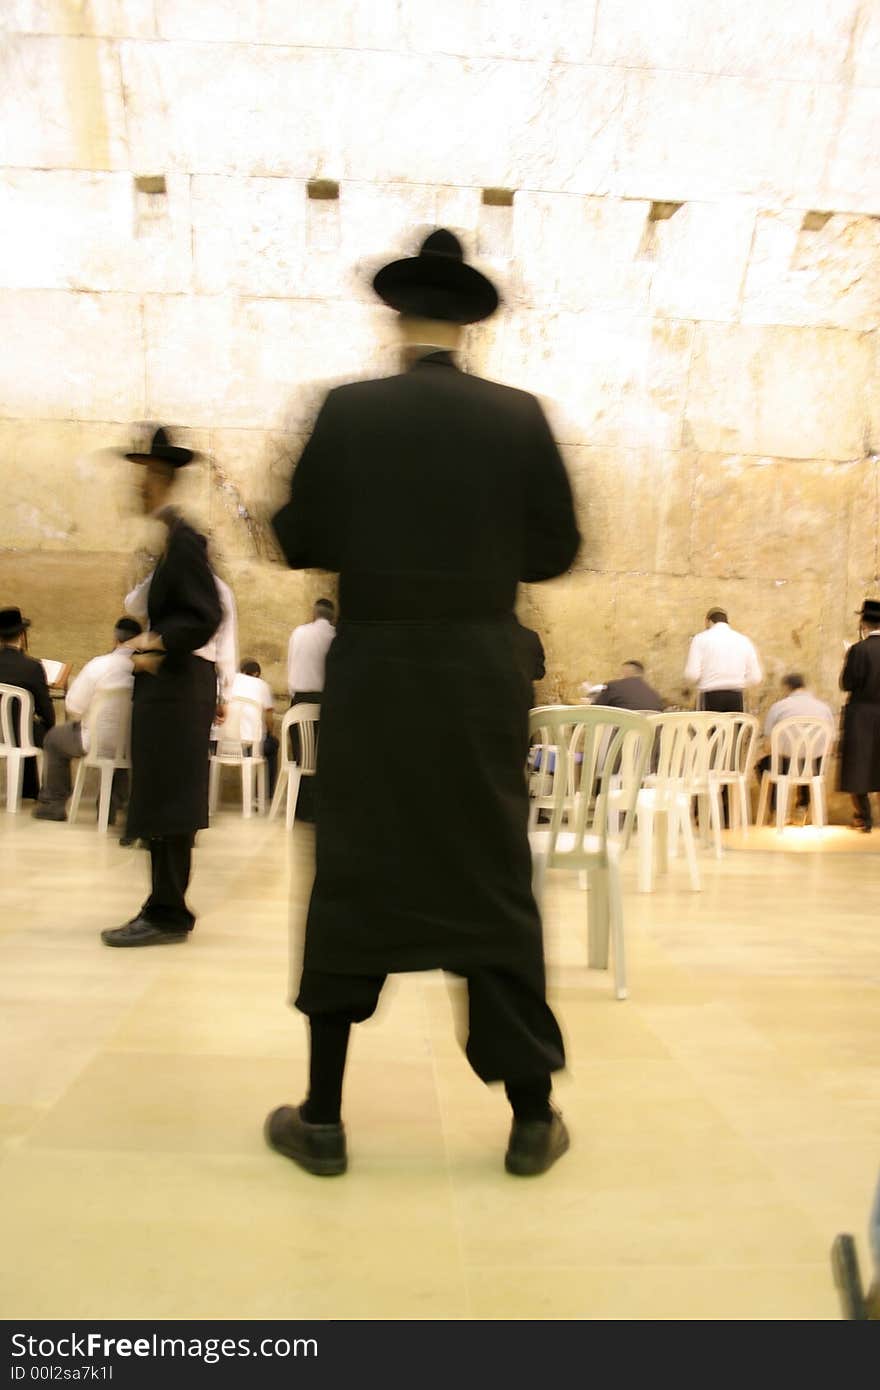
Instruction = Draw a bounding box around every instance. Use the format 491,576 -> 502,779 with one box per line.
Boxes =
840,599 -> 880,833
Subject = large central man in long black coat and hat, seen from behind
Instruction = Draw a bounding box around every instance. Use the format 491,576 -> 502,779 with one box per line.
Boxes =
267,231 -> 580,1175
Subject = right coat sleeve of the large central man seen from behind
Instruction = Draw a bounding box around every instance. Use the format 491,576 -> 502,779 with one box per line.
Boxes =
520,398 -> 581,584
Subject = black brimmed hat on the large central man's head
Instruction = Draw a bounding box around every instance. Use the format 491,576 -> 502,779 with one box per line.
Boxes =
373,227 -> 498,324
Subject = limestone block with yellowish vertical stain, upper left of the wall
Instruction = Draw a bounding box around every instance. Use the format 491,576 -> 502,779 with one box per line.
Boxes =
0,36 -> 128,170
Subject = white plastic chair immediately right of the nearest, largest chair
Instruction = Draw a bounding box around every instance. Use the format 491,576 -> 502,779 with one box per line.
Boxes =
635,710 -> 708,892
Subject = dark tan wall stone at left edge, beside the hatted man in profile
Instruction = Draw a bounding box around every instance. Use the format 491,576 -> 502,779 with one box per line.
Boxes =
0,549 -> 133,673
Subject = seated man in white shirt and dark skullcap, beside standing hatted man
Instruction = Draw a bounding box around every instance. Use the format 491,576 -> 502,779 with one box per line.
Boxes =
33,617 -> 142,824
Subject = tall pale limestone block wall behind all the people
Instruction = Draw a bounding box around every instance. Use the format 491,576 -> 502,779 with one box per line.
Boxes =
0,0 -> 880,705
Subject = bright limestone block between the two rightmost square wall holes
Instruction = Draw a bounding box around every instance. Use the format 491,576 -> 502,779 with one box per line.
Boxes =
648,202 -> 755,321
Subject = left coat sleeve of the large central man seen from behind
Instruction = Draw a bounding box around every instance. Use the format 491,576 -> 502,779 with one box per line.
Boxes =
272,391 -> 343,570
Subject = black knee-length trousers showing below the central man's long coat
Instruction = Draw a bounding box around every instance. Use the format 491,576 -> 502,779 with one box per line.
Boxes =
296,969 -> 566,1084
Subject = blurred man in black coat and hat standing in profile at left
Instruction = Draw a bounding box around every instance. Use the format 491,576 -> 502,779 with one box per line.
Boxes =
101,430 -> 222,947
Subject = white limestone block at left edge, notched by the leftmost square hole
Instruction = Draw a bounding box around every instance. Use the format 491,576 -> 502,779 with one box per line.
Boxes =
0,170 -> 192,292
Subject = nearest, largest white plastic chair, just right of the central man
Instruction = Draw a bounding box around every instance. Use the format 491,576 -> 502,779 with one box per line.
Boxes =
528,705 -> 652,999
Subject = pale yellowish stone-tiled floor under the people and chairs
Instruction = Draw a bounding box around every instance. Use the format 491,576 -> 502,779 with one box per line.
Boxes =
0,812 -> 880,1319
